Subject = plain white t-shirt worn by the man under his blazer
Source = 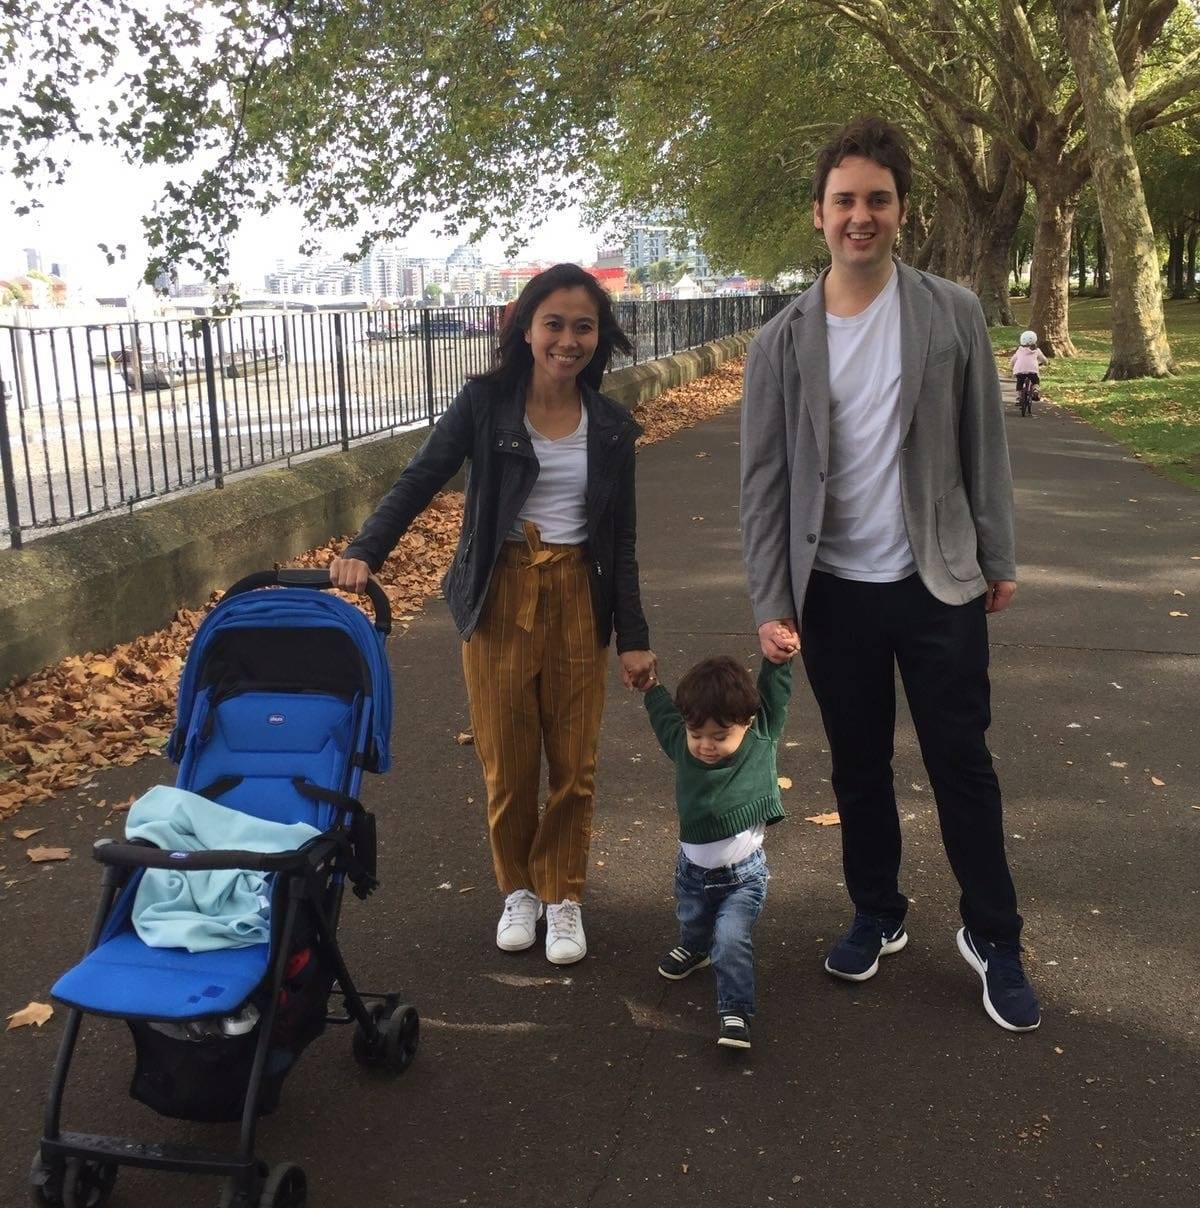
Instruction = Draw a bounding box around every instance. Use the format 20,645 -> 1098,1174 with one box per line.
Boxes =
815,267 -> 916,583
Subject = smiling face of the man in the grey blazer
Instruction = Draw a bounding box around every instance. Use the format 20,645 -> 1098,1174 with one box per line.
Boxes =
812,155 -> 905,275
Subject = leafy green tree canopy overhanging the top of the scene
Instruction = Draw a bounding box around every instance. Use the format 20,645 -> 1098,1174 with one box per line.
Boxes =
7,0 -> 1195,289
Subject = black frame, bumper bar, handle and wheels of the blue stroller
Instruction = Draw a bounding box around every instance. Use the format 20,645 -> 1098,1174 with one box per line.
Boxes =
31,570 -> 419,1208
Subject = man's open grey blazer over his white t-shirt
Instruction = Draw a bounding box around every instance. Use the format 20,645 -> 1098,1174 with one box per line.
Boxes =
742,261 -> 1016,625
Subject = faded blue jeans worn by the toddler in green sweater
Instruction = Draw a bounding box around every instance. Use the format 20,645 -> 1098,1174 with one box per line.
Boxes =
676,848 -> 766,1018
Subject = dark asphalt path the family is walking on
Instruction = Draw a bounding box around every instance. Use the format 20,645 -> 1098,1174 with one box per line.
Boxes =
0,391 -> 1200,1208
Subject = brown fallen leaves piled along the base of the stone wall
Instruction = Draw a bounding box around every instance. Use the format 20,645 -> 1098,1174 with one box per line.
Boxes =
0,361 -> 742,818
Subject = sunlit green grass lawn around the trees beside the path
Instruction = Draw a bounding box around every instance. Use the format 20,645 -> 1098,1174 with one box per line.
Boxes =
992,298 -> 1200,489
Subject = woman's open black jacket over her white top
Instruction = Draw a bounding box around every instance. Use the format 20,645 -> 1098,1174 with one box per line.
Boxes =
344,381 -> 650,654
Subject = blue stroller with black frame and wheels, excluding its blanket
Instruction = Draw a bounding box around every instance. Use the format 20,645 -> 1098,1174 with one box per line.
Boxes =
31,570 -> 421,1208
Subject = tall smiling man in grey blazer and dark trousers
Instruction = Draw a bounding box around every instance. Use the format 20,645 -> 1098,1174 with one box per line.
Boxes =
742,117 -> 1040,1032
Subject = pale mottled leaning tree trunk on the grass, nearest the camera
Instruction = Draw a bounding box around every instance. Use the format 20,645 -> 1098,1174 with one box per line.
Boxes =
1059,0 -> 1175,381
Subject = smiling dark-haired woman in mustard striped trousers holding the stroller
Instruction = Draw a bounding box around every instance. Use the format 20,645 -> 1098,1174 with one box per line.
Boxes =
330,265 -> 656,965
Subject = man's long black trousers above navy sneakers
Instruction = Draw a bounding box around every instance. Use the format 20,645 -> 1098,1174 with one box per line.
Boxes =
802,571 -> 1021,942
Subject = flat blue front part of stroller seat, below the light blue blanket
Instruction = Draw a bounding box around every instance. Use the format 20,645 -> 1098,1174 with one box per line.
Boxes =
52,928 -> 271,1020
